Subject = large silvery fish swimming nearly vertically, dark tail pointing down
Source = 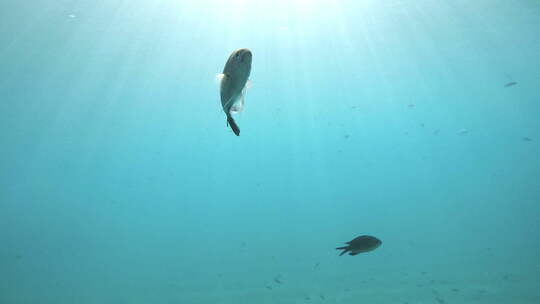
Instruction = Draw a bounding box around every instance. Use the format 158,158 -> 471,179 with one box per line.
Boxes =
219,49 -> 253,136
